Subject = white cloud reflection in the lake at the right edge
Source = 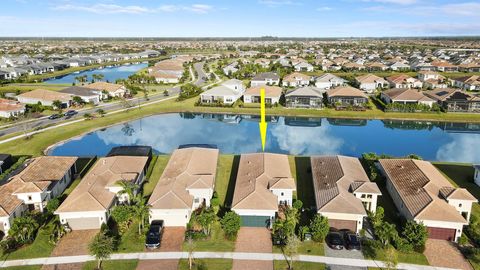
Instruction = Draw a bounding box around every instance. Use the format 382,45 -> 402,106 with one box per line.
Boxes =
437,134 -> 480,163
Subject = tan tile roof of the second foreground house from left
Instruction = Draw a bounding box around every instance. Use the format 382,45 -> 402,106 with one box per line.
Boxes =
56,156 -> 148,213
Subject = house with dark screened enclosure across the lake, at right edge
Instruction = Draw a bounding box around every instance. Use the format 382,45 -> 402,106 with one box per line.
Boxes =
424,88 -> 480,112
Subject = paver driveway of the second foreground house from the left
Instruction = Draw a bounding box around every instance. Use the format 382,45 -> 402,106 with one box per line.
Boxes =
42,230 -> 99,270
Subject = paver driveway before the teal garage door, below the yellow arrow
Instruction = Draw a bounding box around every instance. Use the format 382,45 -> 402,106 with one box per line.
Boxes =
233,227 -> 273,270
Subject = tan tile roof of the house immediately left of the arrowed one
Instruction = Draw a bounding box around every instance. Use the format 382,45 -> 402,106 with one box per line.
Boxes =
148,147 -> 219,209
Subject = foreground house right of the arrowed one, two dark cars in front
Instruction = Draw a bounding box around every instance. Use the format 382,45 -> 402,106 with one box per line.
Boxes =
310,156 -> 382,233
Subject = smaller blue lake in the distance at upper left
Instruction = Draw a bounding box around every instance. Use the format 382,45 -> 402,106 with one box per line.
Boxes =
44,63 -> 148,84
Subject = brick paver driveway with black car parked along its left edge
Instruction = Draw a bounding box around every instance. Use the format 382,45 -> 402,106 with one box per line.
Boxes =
137,227 -> 185,270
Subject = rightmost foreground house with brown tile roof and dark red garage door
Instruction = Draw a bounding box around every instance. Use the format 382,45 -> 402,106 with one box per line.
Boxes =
378,159 -> 477,241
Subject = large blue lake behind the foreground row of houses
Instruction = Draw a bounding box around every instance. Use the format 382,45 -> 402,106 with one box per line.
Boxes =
49,113 -> 480,163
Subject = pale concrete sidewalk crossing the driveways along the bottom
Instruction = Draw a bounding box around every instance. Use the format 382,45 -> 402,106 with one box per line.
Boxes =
0,252 -> 453,270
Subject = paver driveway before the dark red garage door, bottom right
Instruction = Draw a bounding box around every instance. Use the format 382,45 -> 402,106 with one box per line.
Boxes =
423,239 -> 473,270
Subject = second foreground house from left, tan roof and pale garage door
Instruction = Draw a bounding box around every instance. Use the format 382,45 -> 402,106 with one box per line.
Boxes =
55,156 -> 148,230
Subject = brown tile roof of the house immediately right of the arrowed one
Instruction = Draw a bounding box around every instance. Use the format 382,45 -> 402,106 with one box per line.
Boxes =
310,156 -> 380,215
